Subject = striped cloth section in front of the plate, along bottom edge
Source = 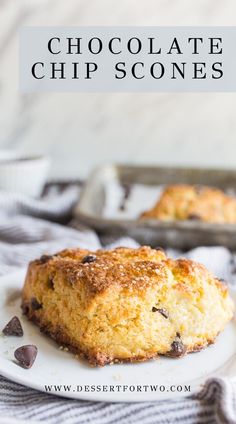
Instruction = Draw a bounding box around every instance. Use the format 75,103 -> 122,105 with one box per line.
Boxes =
0,378 -> 236,424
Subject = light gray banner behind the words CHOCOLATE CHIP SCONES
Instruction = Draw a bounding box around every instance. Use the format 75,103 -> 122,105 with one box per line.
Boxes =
20,27 -> 236,92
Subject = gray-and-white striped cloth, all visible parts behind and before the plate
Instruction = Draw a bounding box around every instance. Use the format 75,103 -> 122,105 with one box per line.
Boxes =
0,189 -> 236,424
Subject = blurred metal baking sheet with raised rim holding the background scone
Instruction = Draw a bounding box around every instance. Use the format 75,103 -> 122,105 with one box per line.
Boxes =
74,165 -> 236,250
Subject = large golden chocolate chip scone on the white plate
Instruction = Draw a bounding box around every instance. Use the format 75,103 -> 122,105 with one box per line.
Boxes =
22,247 -> 233,366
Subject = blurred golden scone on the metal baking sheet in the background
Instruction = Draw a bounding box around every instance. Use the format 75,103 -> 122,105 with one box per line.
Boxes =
141,184 -> 236,224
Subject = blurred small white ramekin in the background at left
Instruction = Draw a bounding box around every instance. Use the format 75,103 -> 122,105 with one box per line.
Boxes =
0,150 -> 50,197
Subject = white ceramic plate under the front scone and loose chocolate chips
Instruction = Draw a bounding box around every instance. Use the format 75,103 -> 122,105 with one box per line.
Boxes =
0,270 -> 236,402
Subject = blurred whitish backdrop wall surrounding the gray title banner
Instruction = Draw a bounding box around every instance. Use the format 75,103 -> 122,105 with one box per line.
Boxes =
0,0 -> 236,178
